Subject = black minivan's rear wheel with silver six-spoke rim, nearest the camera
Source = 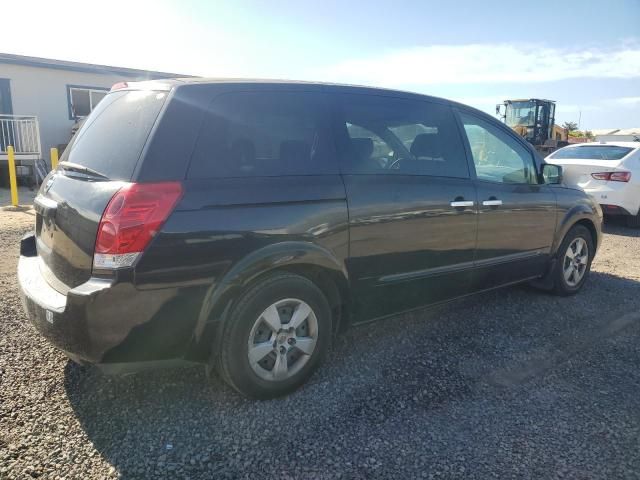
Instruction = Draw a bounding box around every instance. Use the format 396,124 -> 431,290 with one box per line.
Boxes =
212,273 -> 332,399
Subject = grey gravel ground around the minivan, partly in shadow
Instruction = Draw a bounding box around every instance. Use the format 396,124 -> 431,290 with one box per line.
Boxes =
0,210 -> 640,479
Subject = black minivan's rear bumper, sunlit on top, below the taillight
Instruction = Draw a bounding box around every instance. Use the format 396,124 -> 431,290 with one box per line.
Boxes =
18,235 -> 195,371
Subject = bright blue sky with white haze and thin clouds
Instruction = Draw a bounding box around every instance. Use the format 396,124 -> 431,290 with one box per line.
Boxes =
0,0 -> 640,129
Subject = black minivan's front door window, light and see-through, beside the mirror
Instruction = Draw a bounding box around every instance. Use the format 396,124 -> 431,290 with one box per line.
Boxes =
460,112 -> 538,184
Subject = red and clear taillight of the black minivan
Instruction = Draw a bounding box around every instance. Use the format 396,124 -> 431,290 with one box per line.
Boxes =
93,182 -> 182,268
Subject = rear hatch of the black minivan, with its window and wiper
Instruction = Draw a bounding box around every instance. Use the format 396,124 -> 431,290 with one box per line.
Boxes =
34,90 -> 168,293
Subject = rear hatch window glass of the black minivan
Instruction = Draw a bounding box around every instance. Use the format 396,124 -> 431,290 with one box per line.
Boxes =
61,90 -> 167,180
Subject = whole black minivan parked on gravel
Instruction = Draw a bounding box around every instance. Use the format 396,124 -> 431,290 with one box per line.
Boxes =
18,79 -> 602,398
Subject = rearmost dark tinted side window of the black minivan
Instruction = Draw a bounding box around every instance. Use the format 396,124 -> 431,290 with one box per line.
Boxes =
188,91 -> 338,178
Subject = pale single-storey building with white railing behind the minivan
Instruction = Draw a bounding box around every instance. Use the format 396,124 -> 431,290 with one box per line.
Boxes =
0,53 -> 185,183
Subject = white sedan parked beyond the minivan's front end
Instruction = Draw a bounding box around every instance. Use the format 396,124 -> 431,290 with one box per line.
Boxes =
545,142 -> 640,227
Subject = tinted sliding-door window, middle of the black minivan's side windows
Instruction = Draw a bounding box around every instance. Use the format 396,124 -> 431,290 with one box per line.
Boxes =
337,94 -> 469,178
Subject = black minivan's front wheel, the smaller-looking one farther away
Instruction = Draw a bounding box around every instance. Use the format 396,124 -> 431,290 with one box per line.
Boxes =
552,225 -> 595,296
